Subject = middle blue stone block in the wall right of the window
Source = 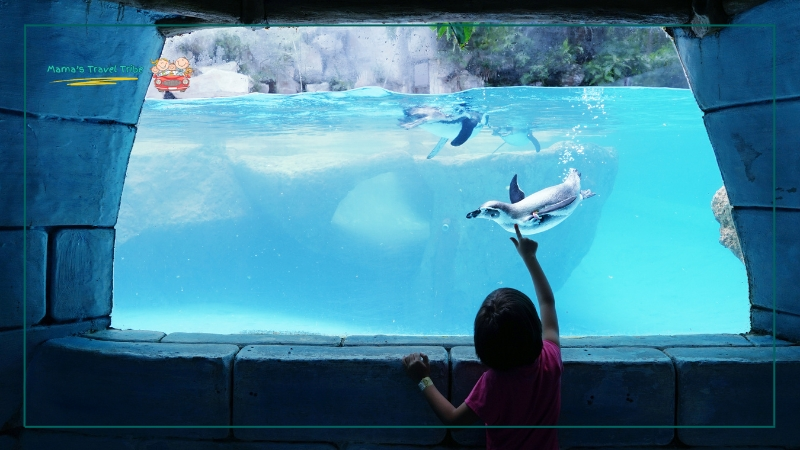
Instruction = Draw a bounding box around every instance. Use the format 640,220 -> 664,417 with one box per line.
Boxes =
703,100 -> 800,208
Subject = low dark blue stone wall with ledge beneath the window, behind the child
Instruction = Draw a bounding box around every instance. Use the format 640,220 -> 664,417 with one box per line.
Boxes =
15,330 -> 800,449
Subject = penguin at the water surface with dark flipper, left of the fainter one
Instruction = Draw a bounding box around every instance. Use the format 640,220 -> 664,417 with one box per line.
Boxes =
400,106 -> 489,159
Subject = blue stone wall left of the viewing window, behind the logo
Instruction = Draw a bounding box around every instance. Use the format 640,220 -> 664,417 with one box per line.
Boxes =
0,1 -> 164,436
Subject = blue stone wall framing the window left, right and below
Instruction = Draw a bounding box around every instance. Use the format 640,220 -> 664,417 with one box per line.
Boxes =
0,0 -> 800,449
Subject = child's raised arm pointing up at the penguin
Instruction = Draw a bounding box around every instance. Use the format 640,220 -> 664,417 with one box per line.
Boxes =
511,225 -> 561,346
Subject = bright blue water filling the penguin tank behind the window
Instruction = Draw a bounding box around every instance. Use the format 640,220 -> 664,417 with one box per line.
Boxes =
112,87 -> 749,335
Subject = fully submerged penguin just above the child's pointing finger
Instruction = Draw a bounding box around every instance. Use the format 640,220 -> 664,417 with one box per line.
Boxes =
467,169 -> 595,234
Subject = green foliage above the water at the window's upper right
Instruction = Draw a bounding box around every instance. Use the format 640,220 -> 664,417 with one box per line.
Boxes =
434,24 -> 677,86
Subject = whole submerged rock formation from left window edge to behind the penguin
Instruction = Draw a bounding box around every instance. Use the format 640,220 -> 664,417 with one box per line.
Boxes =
115,141 -> 618,322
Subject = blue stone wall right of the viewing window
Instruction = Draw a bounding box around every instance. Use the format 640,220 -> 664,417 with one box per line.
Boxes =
673,0 -> 800,340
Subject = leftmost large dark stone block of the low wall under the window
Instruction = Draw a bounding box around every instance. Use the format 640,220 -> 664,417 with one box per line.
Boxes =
27,337 -> 239,439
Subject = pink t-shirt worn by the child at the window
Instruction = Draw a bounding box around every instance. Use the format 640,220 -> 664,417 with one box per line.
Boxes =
464,340 -> 564,450
